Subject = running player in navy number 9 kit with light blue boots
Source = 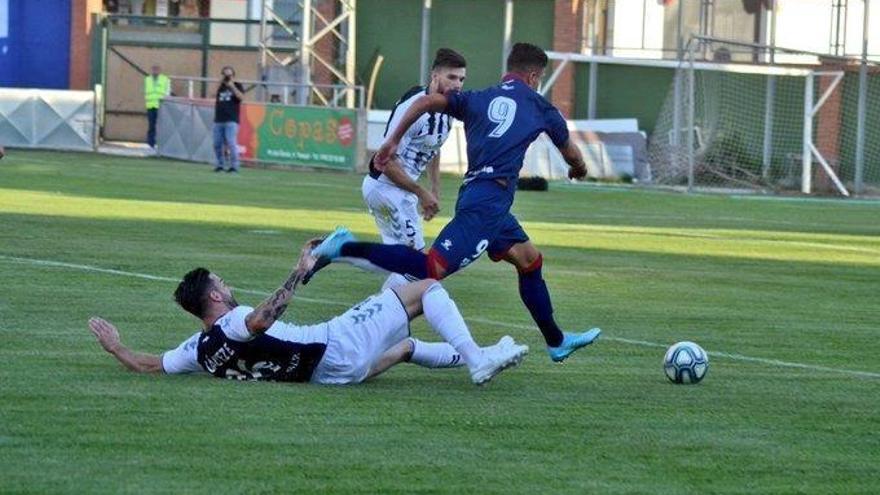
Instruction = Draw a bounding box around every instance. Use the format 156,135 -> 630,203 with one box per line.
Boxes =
306,43 -> 601,362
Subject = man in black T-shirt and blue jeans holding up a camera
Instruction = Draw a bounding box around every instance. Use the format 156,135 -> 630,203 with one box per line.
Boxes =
214,65 -> 244,173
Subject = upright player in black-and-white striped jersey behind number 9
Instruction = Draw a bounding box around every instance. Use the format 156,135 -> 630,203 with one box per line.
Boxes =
362,48 -> 467,287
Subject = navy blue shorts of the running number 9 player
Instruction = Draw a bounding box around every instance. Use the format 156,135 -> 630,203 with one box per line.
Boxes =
429,180 -> 529,275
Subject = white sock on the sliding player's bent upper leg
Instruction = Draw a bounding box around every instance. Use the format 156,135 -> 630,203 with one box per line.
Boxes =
422,284 -> 483,369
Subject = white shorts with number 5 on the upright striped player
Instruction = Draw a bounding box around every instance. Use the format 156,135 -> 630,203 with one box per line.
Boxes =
361,175 -> 425,250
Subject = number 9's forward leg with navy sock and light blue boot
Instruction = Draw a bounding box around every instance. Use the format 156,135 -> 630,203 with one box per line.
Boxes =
504,241 -> 602,362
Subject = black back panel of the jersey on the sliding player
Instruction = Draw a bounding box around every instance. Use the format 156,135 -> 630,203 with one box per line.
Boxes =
197,325 -> 327,382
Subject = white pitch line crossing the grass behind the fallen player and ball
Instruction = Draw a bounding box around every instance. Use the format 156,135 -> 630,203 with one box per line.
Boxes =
0,254 -> 880,378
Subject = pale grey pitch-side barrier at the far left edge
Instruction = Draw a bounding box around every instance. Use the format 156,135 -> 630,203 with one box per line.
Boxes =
0,88 -> 100,151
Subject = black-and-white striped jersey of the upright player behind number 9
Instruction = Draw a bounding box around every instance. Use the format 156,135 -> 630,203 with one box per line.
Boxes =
371,86 -> 453,184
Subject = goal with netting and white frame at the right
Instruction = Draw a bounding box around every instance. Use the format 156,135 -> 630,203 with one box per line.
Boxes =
648,39 -> 880,196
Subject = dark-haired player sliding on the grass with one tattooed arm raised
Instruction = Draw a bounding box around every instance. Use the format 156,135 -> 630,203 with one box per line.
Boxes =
89,238 -> 529,385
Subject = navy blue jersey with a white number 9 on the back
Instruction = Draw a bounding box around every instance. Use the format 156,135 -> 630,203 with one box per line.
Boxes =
446,76 -> 568,183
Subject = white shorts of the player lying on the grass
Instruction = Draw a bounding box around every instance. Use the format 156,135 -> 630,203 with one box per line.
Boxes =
311,289 -> 409,385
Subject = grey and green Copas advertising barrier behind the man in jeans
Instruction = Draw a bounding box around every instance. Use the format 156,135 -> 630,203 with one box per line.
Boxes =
157,97 -> 367,171
